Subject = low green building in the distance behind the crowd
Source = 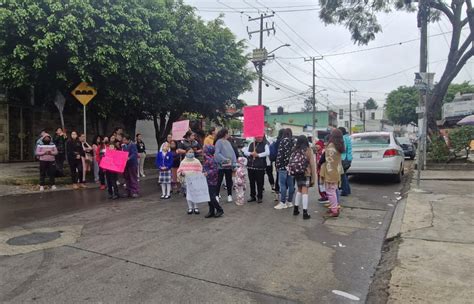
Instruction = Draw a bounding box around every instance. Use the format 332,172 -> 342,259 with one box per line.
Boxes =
265,110 -> 337,136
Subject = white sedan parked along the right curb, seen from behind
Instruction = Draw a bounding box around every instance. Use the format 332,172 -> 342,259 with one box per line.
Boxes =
348,132 -> 405,183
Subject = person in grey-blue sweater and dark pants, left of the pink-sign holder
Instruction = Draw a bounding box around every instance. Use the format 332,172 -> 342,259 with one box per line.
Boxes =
215,128 -> 237,203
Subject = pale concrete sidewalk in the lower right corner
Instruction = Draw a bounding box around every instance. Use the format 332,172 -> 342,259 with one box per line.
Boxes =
388,171 -> 474,303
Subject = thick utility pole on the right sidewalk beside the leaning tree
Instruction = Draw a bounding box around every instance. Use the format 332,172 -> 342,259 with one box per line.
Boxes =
416,0 -> 429,188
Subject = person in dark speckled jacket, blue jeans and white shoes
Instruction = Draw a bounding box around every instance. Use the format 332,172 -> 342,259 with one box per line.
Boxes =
274,129 -> 295,210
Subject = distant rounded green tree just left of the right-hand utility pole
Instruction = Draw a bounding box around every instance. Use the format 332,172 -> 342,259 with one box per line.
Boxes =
385,86 -> 418,125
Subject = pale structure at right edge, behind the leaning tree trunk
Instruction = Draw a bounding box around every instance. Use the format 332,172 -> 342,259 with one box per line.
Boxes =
438,93 -> 474,128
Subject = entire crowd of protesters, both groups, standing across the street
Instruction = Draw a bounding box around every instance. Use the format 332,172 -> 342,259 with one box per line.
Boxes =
36,127 -> 352,219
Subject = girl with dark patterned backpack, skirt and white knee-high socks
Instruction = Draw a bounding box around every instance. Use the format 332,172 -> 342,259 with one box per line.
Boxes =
288,135 -> 316,220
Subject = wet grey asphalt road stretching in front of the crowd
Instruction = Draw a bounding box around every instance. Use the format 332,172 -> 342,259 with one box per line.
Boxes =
0,162 -> 411,303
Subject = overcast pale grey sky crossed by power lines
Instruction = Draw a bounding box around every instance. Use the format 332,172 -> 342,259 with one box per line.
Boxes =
185,0 -> 474,111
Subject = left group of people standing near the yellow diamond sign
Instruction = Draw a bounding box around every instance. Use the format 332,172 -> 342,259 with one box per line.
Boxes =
35,128 -> 146,199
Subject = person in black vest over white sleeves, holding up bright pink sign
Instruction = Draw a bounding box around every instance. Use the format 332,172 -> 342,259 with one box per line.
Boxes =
244,136 -> 270,203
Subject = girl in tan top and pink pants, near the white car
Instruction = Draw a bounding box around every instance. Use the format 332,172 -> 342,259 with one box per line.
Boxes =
320,129 -> 344,217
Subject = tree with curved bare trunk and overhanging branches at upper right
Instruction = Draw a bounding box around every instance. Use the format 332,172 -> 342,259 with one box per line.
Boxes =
319,0 -> 474,132
